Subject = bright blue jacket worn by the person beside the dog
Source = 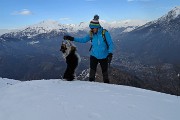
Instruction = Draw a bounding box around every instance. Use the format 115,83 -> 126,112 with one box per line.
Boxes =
74,27 -> 114,59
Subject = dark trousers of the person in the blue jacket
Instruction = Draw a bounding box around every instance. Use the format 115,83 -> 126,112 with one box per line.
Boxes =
89,56 -> 109,83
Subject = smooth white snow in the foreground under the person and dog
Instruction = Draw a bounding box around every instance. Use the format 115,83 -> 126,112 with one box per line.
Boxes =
0,78 -> 180,120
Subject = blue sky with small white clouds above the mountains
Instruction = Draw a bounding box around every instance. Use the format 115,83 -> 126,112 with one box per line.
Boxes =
0,0 -> 180,29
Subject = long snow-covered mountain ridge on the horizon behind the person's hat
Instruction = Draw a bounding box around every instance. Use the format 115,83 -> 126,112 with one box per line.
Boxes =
1,20 -> 147,39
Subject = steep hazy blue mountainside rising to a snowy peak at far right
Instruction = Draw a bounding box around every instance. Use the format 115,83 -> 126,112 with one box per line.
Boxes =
116,7 -> 180,64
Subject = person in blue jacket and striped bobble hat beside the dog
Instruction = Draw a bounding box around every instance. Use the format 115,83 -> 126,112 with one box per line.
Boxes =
64,15 -> 114,83
